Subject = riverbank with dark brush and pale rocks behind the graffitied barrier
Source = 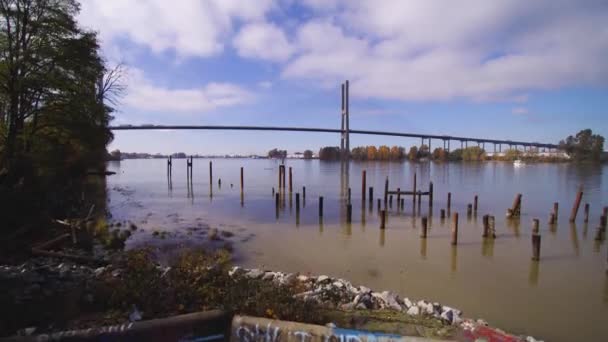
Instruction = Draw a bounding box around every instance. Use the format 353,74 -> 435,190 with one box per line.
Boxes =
0,230 -> 534,341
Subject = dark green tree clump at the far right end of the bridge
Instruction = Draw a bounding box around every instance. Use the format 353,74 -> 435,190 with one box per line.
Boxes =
559,129 -> 605,161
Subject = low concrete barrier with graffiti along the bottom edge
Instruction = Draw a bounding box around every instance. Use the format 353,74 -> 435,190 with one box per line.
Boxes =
0,310 -> 446,342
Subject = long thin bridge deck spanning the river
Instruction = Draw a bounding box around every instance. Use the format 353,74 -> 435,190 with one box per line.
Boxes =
110,125 -> 558,148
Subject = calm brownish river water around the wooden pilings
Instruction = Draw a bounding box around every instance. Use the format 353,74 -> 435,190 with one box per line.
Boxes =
108,159 -> 608,341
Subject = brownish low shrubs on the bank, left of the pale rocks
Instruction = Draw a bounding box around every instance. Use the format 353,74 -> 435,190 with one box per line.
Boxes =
104,249 -> 322,323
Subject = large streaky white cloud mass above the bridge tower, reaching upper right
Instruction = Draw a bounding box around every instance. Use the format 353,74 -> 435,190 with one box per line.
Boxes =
282,0 -> 608,102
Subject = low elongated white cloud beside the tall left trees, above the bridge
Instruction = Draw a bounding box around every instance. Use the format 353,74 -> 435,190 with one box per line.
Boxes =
123,69 -> 254,113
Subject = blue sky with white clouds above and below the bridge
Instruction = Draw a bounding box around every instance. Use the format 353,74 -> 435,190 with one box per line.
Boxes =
78,0 -> 608,154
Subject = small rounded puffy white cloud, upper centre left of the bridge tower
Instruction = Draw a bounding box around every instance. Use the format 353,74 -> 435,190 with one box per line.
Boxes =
233,22 -> 293,61
